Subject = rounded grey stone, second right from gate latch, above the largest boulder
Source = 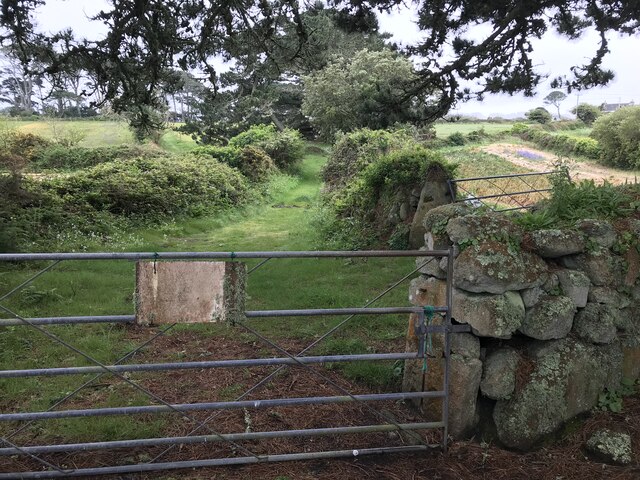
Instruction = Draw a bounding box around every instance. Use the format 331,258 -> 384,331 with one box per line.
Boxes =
519,295 -> 576,340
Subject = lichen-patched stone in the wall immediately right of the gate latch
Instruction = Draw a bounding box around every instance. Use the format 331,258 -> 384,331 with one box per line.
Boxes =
451,289 -> 525,339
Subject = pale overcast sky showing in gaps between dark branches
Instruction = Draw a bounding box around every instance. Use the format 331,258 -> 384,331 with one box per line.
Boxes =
37,0 -> 640,116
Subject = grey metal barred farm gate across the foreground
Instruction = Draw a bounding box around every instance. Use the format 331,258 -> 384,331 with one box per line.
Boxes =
0,250 -> 466,479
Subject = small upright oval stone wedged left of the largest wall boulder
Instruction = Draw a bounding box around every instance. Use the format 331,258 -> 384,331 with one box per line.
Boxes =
480,348 -> 520,400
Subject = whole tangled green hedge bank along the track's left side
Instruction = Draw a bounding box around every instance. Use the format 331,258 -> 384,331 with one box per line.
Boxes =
0,126 -> 304,251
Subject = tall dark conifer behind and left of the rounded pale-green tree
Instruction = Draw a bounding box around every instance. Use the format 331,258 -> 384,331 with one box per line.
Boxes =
181,2 -> 388,143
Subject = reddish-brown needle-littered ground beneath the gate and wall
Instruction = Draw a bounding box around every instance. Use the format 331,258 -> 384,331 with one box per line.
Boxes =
0,330 -> 640,480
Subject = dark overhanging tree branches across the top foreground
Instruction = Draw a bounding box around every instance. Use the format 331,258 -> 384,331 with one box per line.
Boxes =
0,0 -> 640,138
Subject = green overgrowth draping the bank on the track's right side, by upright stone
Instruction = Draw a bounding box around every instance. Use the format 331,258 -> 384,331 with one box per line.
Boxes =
321,129 -> 455,248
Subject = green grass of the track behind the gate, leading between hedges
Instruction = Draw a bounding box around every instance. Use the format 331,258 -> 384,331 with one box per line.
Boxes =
0,146 -> 414,441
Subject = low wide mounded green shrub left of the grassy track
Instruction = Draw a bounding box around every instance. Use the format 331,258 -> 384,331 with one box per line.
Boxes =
42,157 -> 248,217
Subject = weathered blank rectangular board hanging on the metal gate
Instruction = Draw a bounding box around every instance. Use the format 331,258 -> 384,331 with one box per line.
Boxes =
135,262 -> 247,325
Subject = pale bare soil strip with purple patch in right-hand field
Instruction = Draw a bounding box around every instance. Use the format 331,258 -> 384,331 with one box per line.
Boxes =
481,143 -> 640,185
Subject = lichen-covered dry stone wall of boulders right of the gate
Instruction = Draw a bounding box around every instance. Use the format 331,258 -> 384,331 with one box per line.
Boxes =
404,204 -> 640,449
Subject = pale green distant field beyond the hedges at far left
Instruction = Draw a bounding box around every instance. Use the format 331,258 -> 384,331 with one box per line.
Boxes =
1,119 -> 195,152
